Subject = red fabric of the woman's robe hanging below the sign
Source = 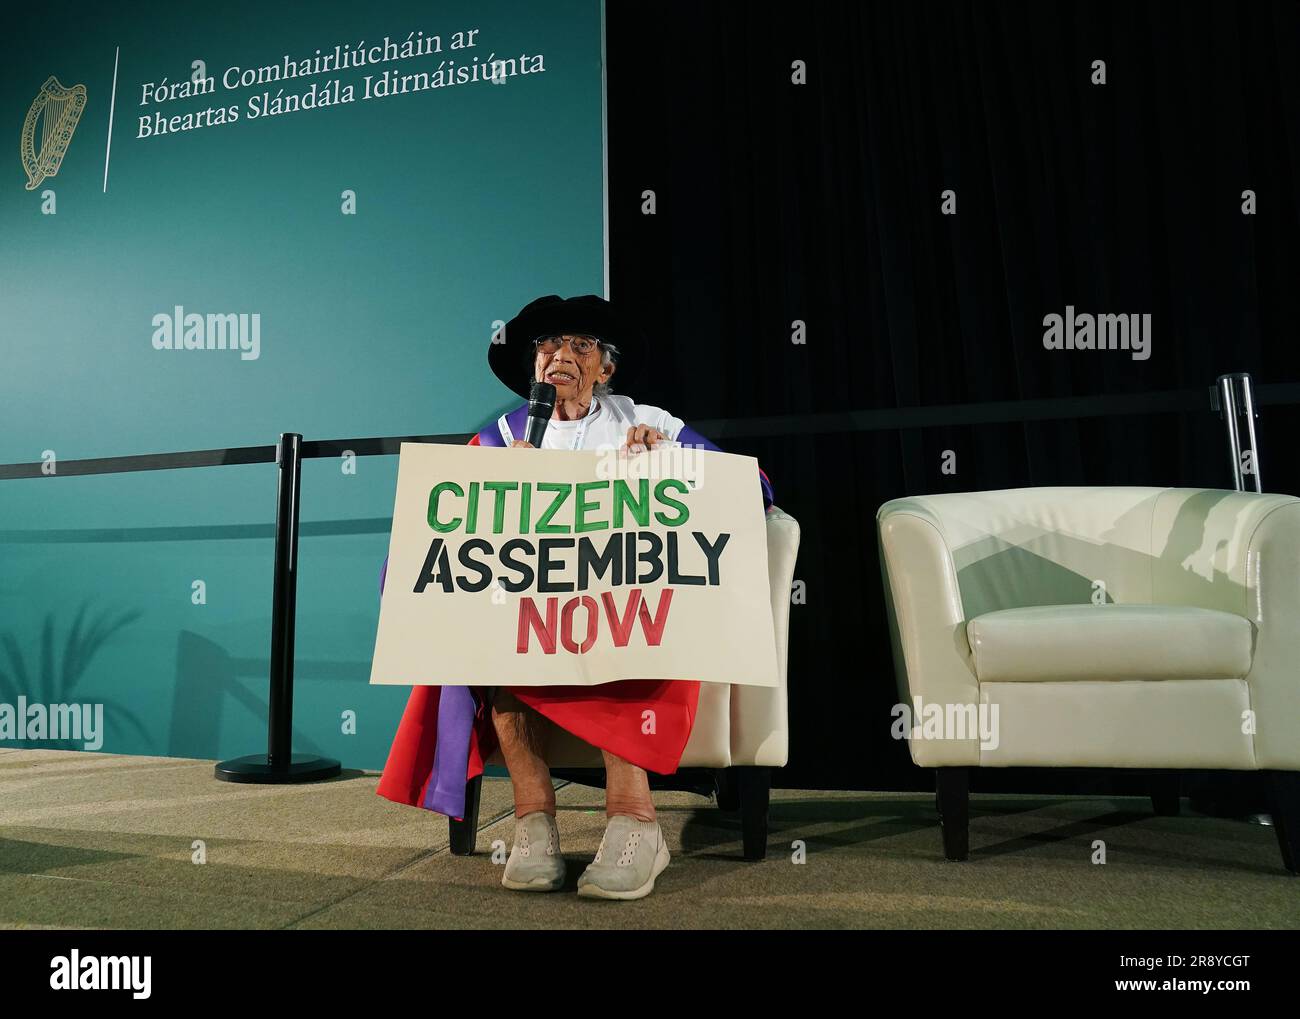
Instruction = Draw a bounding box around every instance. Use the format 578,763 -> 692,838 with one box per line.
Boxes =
374,435 -> 699,807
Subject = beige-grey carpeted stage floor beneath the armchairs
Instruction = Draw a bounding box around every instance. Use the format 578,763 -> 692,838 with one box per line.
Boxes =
0,750 -> 1300,929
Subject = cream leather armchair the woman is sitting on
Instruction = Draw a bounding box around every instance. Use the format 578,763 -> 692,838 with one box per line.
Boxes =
450,506 -> 800,859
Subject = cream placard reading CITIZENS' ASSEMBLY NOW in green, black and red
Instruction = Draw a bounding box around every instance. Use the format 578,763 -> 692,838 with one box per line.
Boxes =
371,442 -> 777,686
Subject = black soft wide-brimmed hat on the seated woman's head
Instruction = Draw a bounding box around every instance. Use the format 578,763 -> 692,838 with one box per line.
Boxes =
488,294 -> 640,399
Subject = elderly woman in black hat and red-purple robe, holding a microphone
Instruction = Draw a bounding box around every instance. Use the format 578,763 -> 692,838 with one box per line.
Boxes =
377,295 -> 772,899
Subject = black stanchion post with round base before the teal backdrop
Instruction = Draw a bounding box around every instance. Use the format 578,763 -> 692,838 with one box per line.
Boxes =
216,432 -> 341,782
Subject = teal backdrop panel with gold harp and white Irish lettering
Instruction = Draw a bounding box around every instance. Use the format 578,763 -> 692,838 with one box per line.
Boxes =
0,0 -> 607,768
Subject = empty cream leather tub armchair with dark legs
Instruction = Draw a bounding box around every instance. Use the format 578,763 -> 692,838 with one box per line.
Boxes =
876,487 -> 1300,872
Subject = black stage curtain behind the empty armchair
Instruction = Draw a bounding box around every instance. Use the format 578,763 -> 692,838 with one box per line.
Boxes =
607,0 -> 1300,792
